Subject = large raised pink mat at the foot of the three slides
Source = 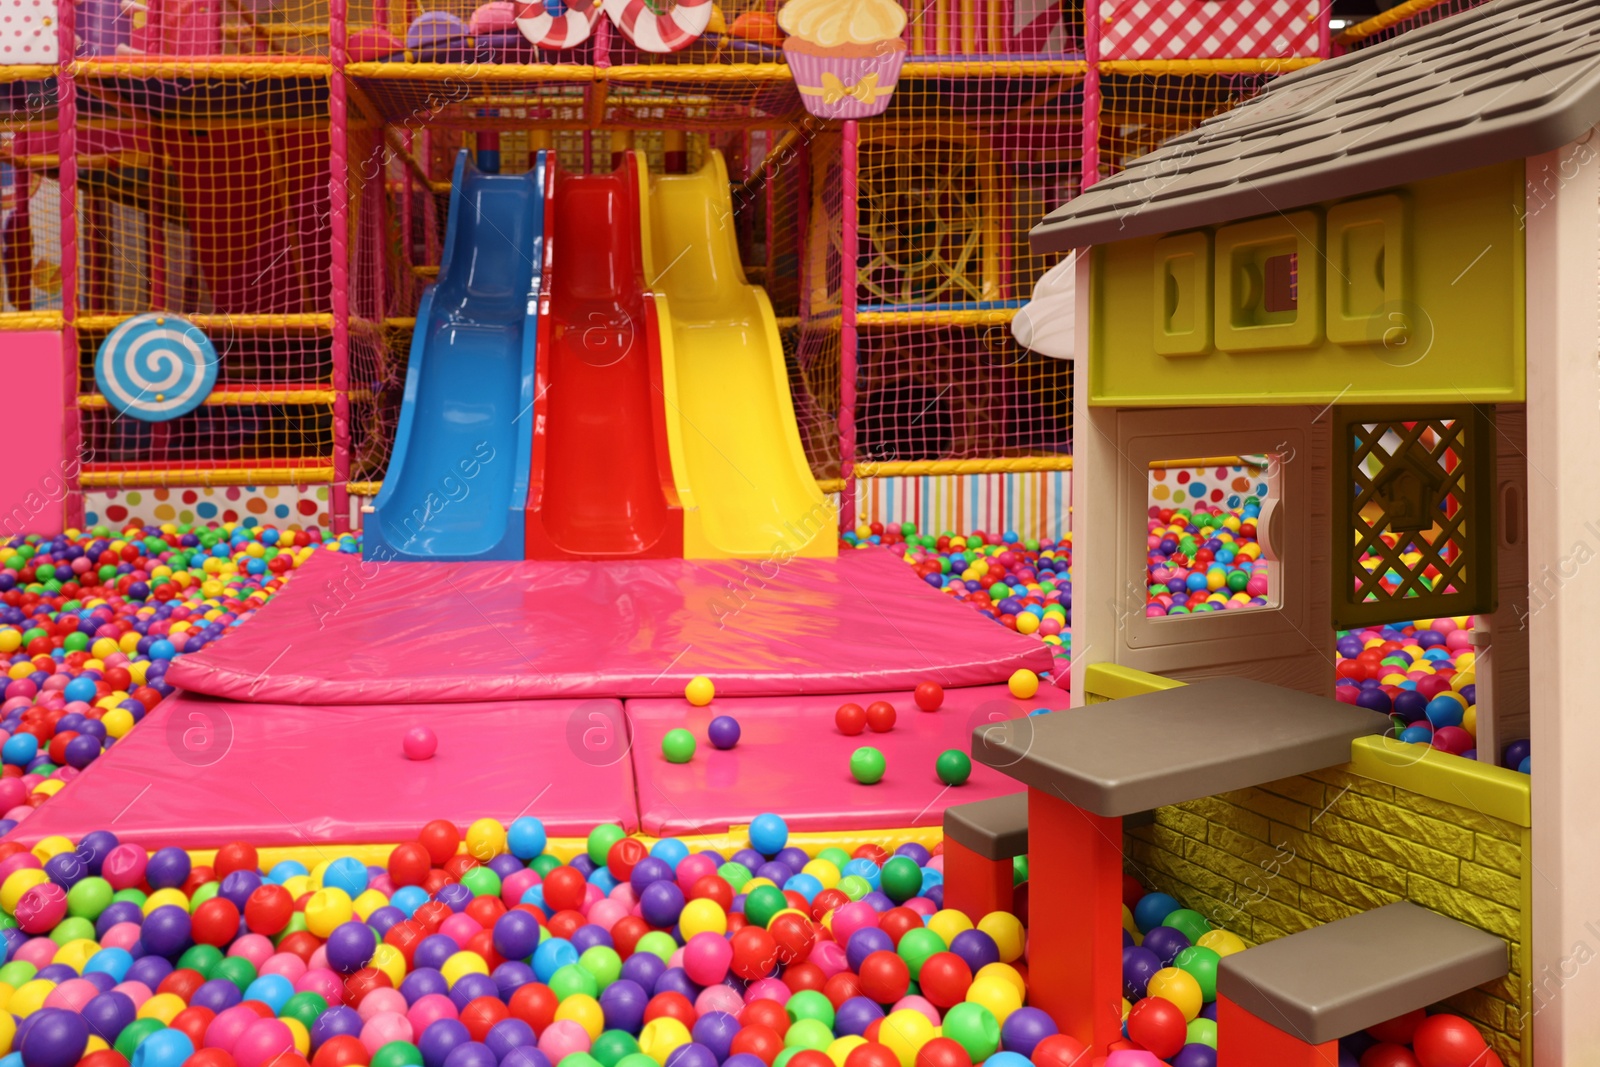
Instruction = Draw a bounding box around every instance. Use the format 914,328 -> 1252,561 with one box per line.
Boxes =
166,552 -> 1051,704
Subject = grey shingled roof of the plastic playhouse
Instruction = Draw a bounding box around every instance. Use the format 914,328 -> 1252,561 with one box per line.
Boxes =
1032,0 -> 1600,251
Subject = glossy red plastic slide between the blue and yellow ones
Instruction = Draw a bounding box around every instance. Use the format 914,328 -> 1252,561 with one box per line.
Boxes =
526,154 -> 683,560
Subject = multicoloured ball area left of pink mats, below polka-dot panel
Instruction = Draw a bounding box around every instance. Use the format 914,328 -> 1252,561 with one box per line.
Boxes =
0,523 -> 321,833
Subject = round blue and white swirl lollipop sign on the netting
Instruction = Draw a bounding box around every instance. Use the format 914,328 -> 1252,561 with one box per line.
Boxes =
94,312 -> 218,422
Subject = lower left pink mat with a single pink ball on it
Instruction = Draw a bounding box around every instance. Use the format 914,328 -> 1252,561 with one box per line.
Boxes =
8,694 -> 638,848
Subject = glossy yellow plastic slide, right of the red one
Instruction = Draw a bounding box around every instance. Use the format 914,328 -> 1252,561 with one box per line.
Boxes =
645,152 -> 838,561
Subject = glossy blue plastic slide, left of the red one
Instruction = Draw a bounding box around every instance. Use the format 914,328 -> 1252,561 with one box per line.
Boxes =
365,150 -> 546,560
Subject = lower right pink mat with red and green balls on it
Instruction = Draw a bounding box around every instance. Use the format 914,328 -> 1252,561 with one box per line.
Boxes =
626,685 -> 1069,837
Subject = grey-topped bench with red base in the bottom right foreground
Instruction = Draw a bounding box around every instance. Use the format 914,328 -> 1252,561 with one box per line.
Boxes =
1216,901 -> 1509,1067
